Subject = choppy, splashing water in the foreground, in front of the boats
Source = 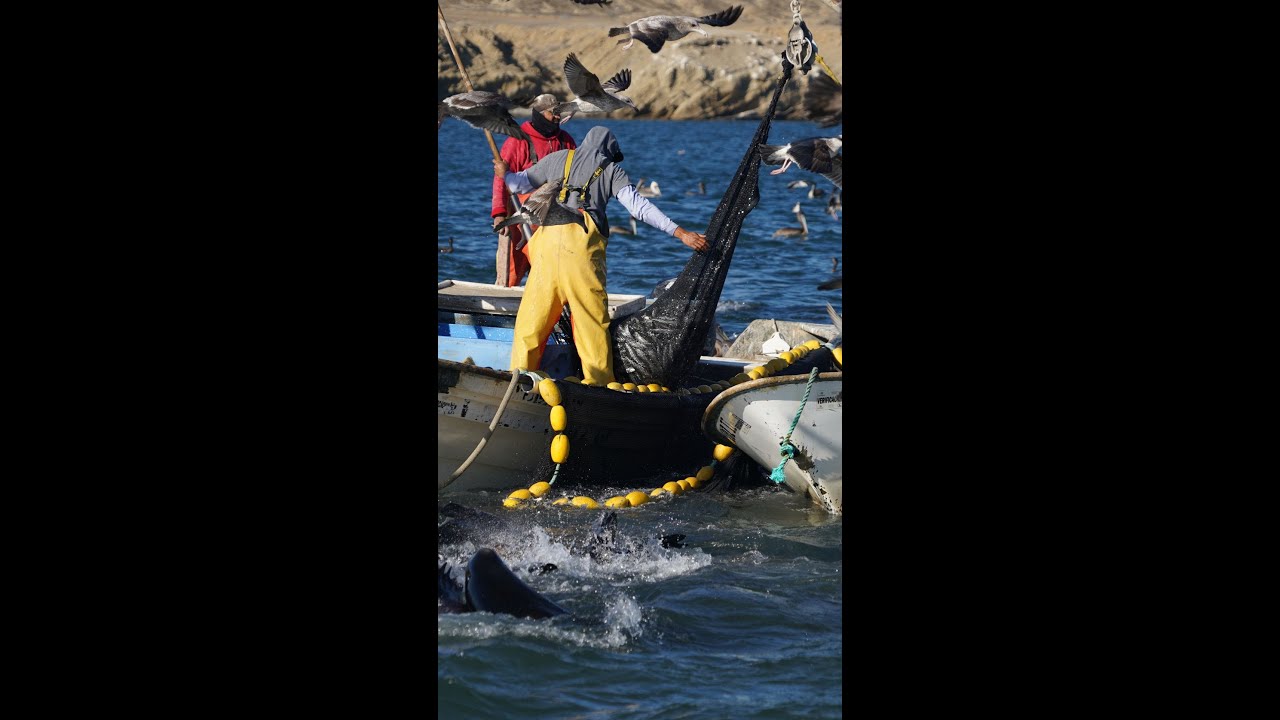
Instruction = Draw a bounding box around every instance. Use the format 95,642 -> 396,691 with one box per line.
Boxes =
436,488 -> 844,720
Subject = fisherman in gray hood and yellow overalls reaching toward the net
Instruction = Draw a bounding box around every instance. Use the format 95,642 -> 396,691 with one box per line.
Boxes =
493,126 -> 708,386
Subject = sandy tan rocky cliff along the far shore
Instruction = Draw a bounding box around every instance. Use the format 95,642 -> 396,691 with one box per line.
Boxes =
436,0 -> 845,119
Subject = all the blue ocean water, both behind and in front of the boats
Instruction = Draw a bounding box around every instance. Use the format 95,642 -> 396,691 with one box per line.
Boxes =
436,116 -> 844,720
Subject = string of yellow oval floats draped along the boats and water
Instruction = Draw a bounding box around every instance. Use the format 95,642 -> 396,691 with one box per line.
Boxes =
502,340 -> 844,510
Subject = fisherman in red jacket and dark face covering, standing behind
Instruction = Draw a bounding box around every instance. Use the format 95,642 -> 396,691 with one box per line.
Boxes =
490,95 -> 577,287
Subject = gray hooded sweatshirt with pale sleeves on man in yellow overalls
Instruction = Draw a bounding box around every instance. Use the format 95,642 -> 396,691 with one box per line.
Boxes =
506,126 -> 678,237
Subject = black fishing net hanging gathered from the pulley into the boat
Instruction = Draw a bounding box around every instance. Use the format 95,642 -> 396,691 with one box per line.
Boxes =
611,55 -> 792,388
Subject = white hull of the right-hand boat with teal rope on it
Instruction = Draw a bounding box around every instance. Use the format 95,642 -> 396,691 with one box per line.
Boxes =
703,373 -> 844,515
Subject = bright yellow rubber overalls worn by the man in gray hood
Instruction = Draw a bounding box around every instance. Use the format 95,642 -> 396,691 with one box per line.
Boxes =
511,150 -> 613,386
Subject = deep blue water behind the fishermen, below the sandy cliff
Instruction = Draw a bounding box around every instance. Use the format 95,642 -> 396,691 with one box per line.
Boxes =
436,117 -> 844,338
